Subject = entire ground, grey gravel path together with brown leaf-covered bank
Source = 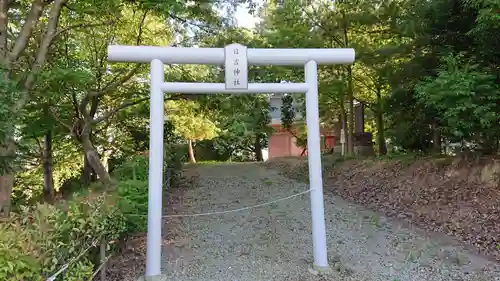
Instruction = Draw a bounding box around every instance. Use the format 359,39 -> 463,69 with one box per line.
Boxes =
104,158 -> 500,281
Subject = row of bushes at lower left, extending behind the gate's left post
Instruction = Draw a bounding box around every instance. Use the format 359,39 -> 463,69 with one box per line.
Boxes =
0,147 -> 183,281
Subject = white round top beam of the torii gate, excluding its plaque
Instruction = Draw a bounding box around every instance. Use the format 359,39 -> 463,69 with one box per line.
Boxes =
108,45 -> 355,66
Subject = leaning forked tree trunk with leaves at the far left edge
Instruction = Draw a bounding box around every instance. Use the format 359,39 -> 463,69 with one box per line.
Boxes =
0,0 -> 73,215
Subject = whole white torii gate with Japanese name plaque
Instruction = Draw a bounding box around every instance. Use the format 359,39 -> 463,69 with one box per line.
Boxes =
108,44 -> 355,279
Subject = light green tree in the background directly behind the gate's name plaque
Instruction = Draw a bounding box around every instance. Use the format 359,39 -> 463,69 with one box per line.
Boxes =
198,27 -> 274,161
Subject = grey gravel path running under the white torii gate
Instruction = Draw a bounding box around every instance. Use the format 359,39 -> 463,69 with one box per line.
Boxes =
159,163 -> 500,281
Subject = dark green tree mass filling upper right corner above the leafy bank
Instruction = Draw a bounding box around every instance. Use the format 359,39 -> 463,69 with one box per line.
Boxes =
378,0 -> 500,153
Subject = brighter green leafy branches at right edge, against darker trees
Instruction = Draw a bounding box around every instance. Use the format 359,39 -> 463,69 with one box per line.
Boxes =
417,52 -> 500,151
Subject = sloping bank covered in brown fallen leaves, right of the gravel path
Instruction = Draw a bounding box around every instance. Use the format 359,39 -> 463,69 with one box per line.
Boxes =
266,155 -> 500,261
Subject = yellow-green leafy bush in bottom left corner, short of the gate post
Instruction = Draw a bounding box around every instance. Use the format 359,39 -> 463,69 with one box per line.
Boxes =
0,193 -> 127,281
